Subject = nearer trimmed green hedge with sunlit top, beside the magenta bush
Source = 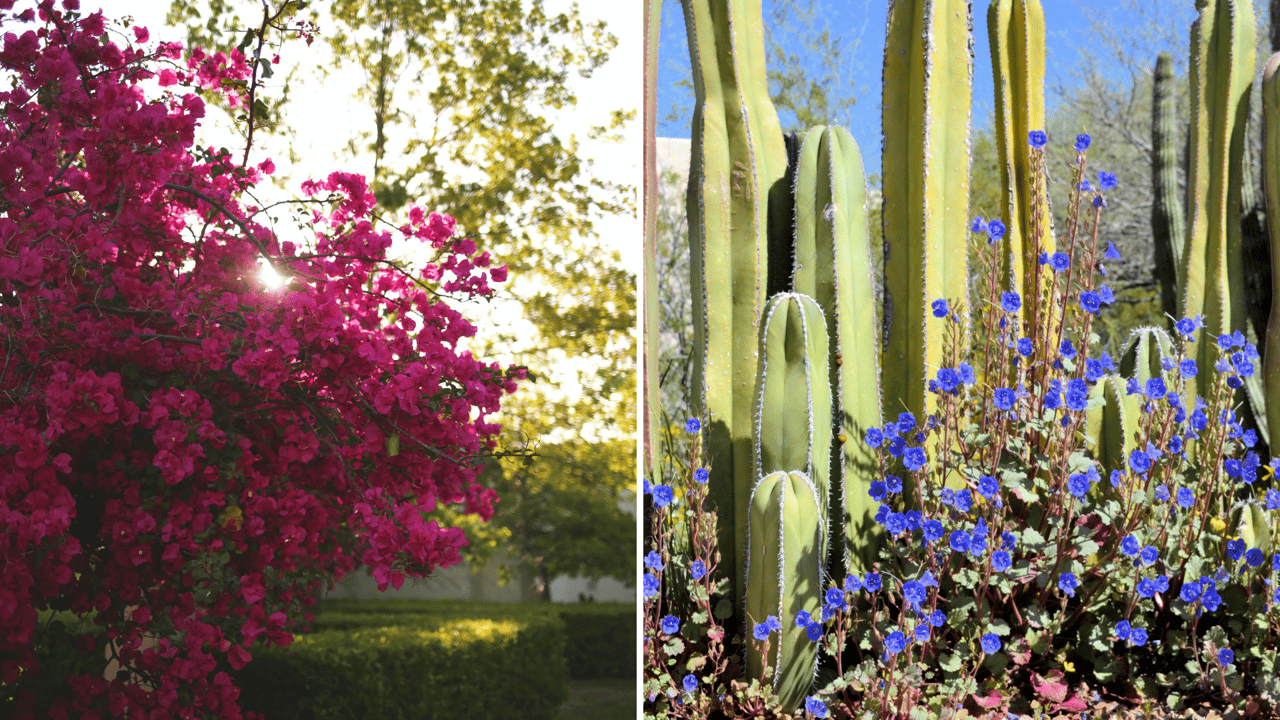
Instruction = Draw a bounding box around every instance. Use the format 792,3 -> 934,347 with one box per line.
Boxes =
236,615 -> 568,720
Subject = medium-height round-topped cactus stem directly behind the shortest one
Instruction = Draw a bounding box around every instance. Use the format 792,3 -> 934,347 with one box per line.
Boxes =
755,292 -> 832,543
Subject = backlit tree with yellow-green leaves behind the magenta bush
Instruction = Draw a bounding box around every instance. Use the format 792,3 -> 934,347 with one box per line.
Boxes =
169,0 -> 635,594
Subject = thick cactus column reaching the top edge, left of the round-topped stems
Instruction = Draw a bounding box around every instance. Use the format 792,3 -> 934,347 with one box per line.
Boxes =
682,0 -> 786,598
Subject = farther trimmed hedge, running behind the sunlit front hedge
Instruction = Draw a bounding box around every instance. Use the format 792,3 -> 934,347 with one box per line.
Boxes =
314,600 -> 629,680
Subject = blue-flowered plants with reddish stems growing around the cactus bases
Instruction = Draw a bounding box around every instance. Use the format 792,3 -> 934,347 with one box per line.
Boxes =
644,132 -> 1280,720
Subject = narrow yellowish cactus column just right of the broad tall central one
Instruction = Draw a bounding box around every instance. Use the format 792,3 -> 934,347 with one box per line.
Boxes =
987,0 -> 1055,316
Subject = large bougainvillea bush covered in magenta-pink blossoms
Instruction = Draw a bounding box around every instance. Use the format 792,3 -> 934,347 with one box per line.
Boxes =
0,0 -> 521,719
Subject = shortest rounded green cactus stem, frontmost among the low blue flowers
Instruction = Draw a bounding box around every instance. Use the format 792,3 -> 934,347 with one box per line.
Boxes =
746,470 -> 824,712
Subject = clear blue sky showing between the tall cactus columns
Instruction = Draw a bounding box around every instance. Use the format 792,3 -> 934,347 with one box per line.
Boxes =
658,0 -> 1198,173
